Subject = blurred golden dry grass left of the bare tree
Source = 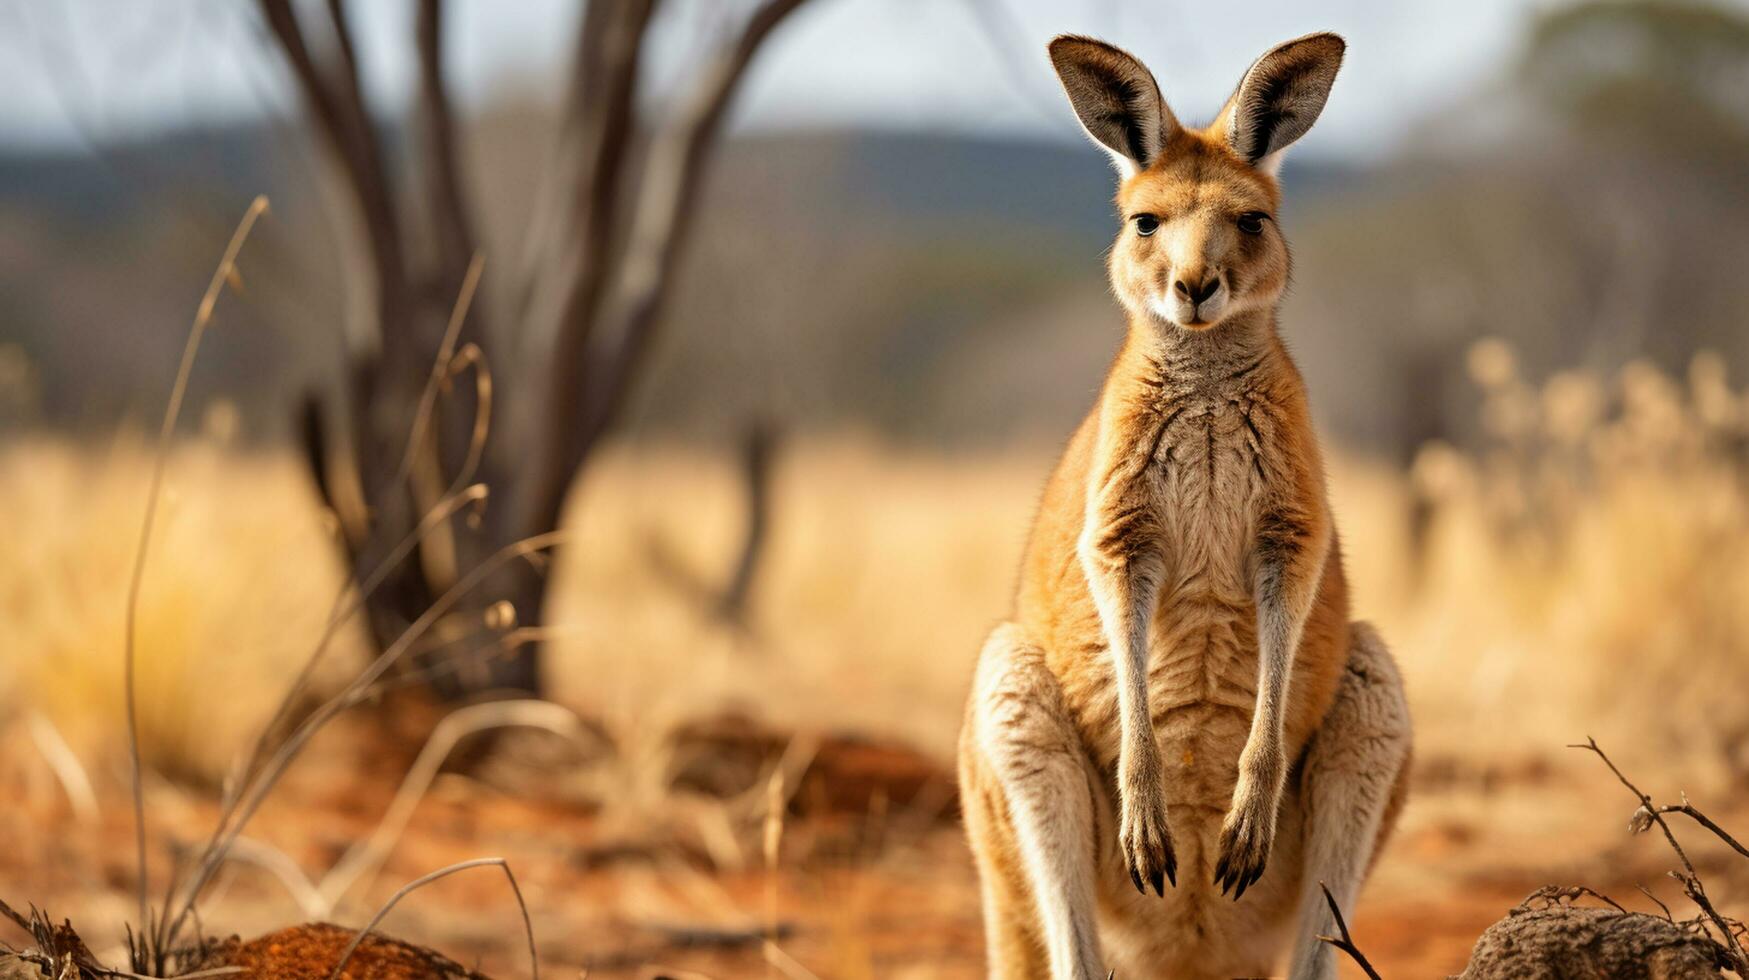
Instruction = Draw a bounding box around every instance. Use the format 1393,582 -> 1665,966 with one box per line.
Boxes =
0,436 -> 362,782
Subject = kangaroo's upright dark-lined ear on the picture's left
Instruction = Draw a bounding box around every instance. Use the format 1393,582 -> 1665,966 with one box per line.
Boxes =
1051,33 -> 1179,177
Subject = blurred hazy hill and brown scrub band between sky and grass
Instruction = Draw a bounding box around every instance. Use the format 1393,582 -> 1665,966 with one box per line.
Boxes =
0,109 -> 1749,455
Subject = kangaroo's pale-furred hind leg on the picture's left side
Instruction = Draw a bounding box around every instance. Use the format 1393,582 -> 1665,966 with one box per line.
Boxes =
960,625 -> 1105,980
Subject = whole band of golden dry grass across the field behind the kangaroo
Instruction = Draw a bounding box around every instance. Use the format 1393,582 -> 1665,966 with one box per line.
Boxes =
0,343 -> 1749,791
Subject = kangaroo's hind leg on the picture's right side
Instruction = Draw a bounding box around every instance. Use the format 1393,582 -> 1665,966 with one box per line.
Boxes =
1291,623 -> 1410,980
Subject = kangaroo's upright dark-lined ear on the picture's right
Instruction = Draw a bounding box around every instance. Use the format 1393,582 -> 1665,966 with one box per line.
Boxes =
1216,33 -> 1348,173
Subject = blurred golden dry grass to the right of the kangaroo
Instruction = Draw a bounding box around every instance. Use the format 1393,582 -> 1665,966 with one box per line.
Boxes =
1345,343 -> 1749,779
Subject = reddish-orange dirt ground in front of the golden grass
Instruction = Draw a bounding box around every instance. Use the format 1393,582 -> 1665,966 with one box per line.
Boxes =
0,707 -> 1749,980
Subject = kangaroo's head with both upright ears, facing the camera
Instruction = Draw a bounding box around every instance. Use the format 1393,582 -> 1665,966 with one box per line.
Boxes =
1051,33 -> 1345,331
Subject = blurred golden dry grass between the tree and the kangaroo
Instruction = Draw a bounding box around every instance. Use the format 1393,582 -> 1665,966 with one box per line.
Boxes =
551,441 -> 1048,758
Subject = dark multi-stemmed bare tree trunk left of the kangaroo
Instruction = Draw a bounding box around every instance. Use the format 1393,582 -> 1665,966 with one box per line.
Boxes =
257,0 -> 803,695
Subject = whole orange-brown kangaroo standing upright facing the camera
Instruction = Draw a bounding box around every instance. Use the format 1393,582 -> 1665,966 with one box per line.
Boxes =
958,33 -> 1410,980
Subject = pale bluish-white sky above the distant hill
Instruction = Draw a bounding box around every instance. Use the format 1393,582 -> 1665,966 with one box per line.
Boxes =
0,0 -> 1721,159
